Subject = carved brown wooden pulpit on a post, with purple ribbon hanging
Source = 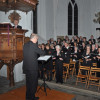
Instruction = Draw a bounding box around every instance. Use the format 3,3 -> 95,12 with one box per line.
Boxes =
0,23 -> 28,86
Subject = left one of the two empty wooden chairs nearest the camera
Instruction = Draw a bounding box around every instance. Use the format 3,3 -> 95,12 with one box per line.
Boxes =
76,66 -> 90,87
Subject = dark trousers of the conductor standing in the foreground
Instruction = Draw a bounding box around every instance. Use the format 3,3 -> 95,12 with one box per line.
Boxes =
26,71 -> 38,100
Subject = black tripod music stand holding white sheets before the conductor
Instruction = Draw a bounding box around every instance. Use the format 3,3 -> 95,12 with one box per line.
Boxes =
37,55 -> 51,96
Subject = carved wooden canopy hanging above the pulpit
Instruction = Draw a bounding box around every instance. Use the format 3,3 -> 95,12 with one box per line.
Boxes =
0,0 -> 38,12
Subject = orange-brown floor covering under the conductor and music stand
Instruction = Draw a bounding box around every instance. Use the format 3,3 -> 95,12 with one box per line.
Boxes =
0,86 -> 75,100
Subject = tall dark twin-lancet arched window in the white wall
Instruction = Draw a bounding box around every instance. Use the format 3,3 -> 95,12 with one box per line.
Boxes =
68,0 -> 78,35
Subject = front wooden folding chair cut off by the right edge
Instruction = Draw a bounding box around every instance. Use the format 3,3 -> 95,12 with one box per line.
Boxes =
88,67 -> 100,91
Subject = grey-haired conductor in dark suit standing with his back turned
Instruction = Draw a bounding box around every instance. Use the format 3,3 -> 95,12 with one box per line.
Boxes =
23,34 -> 45,100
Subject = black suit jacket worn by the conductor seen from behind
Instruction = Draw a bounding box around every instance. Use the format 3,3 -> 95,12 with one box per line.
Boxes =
23,41 -> 45,74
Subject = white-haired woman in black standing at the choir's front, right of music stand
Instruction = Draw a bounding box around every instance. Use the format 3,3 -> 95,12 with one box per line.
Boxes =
53,45 -> 63,83
